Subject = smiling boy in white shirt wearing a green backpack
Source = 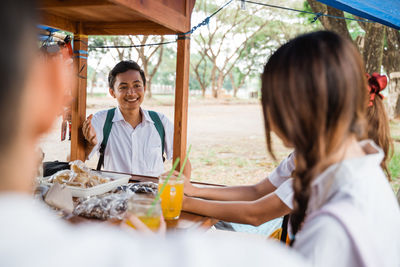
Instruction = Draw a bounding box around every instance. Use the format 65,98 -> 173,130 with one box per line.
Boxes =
82,61 -> 191,177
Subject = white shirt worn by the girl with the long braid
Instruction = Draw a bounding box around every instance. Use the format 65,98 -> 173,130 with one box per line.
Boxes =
294,140 -> 400,267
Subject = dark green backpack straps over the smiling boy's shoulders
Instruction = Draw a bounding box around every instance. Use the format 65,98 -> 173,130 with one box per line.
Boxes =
96,108 -> 165,171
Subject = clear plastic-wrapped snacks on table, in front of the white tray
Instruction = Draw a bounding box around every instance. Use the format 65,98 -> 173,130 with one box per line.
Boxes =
74,193 -> 132,220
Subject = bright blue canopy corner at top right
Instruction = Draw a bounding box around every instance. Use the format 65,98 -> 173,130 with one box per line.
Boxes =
318,0 -> 400,30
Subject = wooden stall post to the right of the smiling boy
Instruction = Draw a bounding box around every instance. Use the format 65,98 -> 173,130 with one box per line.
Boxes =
174,35 -> 190,170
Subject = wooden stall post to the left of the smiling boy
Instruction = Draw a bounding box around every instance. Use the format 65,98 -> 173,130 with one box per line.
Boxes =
71,22 -> 88,161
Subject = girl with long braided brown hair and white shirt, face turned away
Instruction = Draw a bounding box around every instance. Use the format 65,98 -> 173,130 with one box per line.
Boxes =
262,31 -> 400,266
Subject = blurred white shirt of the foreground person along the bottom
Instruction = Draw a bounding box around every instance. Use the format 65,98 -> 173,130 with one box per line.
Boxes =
0,193 -> 310,267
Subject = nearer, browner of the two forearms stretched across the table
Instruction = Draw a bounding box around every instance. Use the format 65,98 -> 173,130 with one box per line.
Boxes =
182,193 -> 291,226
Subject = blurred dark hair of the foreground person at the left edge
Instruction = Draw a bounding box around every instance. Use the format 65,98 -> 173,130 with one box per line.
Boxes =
0,0 -> 38,153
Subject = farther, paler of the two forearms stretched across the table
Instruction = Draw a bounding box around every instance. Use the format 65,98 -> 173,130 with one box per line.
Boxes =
184,177 -> 276,201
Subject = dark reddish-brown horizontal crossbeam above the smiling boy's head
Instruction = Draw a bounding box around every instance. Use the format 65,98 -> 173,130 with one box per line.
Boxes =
83,21 -> 175,35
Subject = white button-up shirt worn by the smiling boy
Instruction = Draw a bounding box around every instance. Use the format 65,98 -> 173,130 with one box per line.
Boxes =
89,107 -> 174,177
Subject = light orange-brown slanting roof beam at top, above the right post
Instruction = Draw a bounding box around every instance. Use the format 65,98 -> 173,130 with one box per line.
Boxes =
110,0 -> 190,32
